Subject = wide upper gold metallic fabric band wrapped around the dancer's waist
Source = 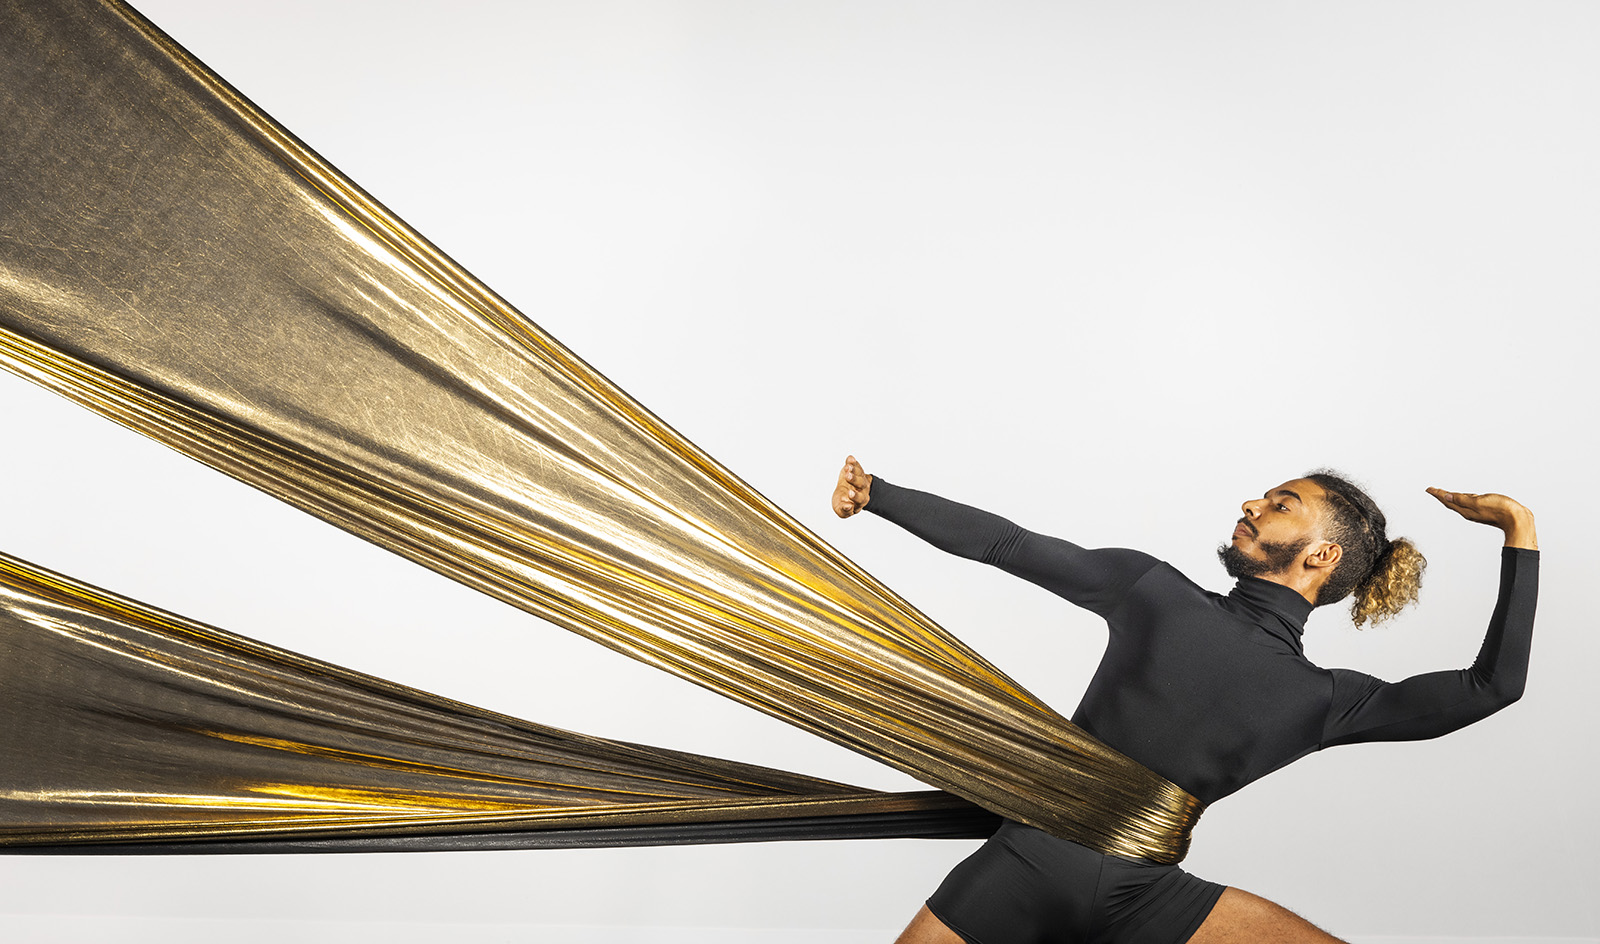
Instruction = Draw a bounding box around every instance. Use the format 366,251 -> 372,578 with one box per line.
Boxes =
0,0 -> 1200,861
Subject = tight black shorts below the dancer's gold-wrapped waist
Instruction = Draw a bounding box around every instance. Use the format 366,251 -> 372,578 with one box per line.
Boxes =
928,821 -> 1224,944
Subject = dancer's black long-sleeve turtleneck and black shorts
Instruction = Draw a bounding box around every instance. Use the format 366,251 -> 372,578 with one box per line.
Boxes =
866,477 -> 1539,944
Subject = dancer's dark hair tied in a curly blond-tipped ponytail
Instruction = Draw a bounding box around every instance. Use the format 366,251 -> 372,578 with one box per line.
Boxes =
1306,469 -> 1427,627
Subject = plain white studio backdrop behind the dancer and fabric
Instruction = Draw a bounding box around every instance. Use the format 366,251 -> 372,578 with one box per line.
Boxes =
0,0 -> 1600,941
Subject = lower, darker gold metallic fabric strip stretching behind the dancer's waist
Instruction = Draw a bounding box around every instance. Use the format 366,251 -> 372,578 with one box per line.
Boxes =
0,555 -> 994,851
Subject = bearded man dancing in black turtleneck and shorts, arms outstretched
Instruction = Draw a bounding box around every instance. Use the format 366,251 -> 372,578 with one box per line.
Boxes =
832,456 -> 1539,944
